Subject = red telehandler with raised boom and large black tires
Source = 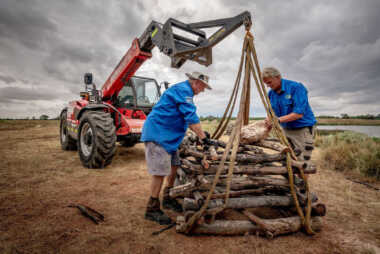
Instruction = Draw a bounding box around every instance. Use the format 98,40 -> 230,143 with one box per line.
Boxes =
60,11 -> 252,168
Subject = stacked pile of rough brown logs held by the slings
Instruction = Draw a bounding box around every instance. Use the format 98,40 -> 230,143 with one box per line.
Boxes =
169,134 -> 326,237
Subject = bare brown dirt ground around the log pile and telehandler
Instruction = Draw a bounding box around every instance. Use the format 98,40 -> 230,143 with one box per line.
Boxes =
0,121 -> 380,254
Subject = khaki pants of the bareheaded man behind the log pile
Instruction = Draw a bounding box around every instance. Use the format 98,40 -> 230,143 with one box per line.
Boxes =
284,126 -> 315,161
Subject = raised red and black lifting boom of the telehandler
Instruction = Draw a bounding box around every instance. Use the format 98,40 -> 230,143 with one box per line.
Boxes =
102,11 -> 252,101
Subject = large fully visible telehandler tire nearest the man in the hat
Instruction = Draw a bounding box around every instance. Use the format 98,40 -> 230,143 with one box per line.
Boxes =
78,111 -> 116,168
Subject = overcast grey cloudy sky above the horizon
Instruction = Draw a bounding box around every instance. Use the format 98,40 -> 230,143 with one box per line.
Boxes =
0,0 -> 380,118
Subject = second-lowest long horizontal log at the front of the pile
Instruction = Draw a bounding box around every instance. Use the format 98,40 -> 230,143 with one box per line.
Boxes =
182,196 -> 304,211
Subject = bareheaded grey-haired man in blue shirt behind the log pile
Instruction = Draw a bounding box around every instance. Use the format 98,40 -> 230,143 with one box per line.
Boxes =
262,67 -> 317,167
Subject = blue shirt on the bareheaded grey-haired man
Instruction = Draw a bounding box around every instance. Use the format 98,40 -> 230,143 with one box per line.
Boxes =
268,79 -> 317,129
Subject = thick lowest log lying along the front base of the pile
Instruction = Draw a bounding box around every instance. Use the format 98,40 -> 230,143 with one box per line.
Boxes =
180,216 -> 322,236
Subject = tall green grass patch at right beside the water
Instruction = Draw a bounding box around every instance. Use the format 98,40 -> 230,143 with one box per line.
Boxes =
315,132 -> 380,180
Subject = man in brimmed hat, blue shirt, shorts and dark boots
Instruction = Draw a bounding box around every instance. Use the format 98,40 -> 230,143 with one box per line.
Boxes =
141,72 -> 211,224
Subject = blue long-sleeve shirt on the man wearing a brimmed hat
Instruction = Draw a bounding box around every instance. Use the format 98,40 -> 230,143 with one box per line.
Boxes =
141,80 -> 199,153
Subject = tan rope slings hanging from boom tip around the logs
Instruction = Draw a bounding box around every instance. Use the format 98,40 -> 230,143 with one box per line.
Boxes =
177,28 -> 315,235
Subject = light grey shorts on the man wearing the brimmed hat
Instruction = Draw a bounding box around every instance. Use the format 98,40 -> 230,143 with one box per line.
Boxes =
145,142 -> 181,176
